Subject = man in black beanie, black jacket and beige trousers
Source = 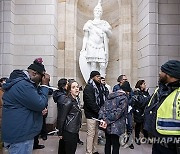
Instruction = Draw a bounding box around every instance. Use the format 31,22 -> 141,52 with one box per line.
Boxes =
83,71 -> 106,154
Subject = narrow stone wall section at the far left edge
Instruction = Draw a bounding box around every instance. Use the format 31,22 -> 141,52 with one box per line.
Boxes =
0,0 -> 15,77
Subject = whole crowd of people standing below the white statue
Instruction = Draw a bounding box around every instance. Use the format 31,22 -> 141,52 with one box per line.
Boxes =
0,58 -> 180,154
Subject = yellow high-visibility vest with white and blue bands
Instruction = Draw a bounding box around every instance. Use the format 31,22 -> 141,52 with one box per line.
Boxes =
154,87 -> 180,135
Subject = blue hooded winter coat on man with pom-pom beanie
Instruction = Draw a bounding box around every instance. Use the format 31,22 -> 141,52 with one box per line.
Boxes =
2,70 -> 49,143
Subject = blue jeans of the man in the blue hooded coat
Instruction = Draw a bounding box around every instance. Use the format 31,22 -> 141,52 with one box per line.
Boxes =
4,139 -> 34,154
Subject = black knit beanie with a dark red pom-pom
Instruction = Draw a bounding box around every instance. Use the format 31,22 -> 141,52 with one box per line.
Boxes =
28,58 -> 46,74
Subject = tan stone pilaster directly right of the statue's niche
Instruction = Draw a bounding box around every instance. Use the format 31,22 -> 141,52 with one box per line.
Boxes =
119,0 -> 137,86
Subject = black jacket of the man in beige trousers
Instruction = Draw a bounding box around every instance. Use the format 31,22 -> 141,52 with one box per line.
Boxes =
83,84 -> 100,119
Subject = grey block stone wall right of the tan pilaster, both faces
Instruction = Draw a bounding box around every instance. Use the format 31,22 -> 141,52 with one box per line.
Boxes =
138,0 -> 180,92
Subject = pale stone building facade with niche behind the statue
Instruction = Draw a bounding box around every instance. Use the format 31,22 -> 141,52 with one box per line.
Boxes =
0,0 -> 180,124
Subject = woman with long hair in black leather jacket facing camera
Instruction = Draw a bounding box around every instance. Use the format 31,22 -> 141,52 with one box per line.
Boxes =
58,80 -> 82,154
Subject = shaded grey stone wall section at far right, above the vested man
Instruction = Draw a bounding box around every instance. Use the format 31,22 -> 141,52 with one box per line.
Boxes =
158,0 -> 180,66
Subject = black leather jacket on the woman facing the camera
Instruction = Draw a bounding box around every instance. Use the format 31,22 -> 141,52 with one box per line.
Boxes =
58,96 -> 82,136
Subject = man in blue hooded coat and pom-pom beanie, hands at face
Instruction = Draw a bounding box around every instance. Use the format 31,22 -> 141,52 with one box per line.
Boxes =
2,58 -> 50,154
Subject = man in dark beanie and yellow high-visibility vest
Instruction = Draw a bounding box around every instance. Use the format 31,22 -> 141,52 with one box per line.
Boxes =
144,60 -> 180,154
